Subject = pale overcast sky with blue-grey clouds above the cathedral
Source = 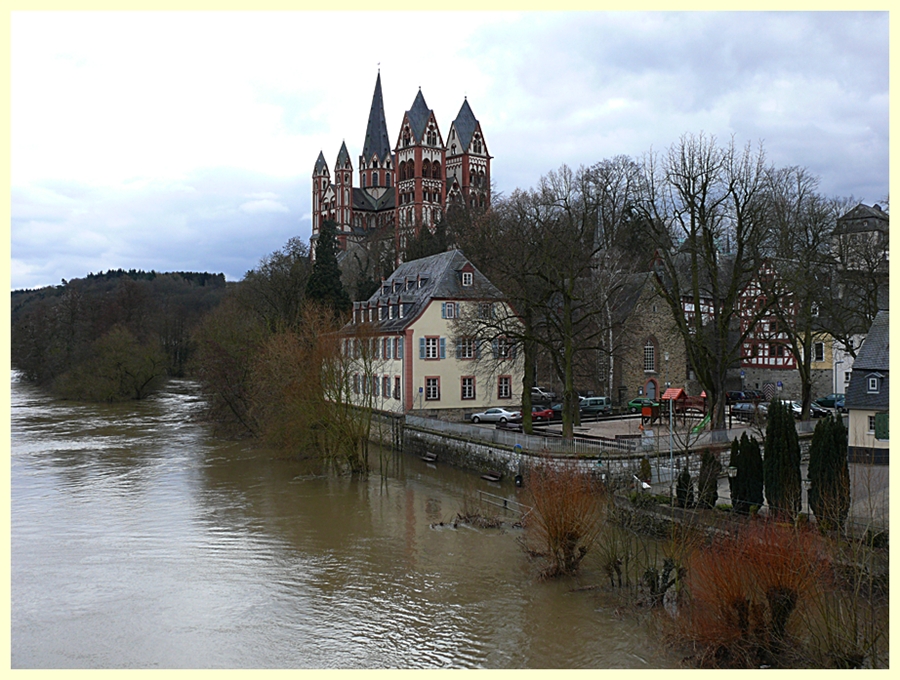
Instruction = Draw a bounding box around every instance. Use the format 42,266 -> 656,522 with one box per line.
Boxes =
11,12 -> 889,289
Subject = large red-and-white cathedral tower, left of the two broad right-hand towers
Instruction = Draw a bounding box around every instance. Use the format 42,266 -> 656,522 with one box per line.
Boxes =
395,90 -> 446,253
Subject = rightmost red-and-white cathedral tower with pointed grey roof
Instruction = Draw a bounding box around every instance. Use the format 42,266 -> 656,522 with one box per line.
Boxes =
447,99 -> 491,210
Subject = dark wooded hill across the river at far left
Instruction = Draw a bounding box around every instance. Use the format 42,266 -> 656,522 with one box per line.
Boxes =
11,269 -> 228,401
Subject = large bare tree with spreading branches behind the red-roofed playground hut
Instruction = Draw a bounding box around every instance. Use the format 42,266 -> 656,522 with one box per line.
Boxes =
636,134 -> 769,429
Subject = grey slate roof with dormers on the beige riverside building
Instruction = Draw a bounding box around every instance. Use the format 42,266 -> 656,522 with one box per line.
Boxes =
345,250 -> 503,333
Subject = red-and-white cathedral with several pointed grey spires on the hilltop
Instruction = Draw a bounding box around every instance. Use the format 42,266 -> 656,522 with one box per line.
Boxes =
310,72 -> 491,261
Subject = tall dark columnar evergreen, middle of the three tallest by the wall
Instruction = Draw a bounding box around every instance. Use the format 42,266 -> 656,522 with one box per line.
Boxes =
763,399 -> 801,519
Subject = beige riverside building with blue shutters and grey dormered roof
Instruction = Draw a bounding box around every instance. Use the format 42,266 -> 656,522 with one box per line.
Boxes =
343,250 -> 524,419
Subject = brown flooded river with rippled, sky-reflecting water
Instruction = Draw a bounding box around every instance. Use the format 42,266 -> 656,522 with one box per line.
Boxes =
10,374 -> 677,669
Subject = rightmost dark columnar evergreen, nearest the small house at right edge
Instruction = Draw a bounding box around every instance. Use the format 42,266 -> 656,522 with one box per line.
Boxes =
808,416 -> 850,529
